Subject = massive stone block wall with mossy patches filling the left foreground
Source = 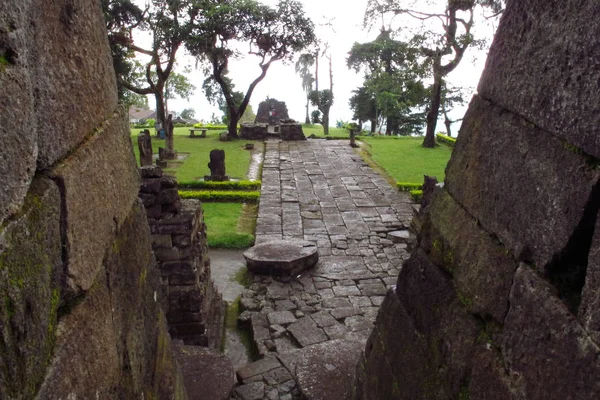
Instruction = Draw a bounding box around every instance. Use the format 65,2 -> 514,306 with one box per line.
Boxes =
0,0 -> 186,399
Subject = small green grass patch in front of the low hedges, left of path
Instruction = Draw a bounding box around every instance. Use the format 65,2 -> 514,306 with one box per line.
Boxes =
202,203 -> 254,249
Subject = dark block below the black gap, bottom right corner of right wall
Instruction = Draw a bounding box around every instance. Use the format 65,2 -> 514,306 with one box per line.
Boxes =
502,264 -> 600,400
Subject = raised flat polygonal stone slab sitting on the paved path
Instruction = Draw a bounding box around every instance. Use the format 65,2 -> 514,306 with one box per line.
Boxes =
244,240 -> 319,277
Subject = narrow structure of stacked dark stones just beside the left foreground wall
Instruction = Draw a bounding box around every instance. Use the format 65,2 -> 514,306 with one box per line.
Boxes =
140,166 -> 225,348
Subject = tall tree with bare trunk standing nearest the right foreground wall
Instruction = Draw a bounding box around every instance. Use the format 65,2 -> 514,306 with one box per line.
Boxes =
365,0 -> 503,147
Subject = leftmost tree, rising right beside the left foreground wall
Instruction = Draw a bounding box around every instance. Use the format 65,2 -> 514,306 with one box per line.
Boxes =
104,0 -> 199,152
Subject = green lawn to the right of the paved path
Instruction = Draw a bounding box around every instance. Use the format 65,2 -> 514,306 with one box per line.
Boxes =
360,136 -> 452,183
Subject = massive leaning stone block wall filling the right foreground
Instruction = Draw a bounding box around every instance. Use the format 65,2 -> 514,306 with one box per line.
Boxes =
354,0 -> 600,400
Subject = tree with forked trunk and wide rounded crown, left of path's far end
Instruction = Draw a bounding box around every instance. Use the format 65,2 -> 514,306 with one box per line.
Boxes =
186,0 -> 315,138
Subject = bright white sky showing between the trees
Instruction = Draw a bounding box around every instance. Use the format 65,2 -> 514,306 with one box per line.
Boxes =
137,0 -> 494,132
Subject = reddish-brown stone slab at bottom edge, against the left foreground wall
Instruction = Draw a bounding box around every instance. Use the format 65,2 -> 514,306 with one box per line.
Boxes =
176,345 -> 233,400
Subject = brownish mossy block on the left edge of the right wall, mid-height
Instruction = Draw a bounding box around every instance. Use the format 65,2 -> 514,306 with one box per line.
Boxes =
421,190 -> 518,323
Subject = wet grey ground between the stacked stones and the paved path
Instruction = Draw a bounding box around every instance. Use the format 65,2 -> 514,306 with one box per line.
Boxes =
208,249 -> 252,369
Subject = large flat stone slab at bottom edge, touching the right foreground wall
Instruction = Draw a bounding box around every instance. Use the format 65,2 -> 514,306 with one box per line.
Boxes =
278,340 -> 365,400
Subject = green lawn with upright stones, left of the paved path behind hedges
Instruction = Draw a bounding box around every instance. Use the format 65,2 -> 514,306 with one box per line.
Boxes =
131,128 -> 255,181
